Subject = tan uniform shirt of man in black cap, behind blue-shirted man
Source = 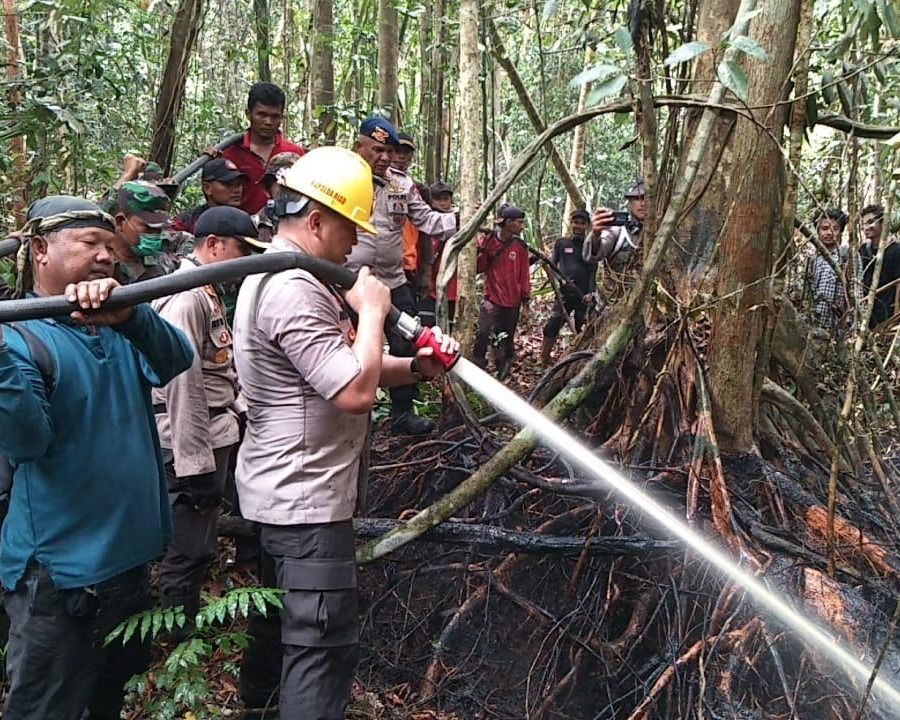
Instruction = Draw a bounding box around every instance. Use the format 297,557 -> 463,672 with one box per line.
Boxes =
153,260 -> 239,477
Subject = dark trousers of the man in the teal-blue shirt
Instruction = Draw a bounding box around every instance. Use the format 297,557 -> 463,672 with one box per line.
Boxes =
3,563 -> 151,720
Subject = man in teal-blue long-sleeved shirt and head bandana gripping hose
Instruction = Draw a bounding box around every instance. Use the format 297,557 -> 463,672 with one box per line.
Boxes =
0,196 -> 193,720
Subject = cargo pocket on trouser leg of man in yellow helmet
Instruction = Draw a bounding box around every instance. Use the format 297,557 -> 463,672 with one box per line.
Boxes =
281,557 -> 359,647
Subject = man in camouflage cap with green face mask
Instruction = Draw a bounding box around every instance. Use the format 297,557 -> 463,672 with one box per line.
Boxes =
113,180 -> 175,285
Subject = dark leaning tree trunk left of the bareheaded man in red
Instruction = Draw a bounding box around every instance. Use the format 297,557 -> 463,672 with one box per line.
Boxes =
149,0 -> 203,174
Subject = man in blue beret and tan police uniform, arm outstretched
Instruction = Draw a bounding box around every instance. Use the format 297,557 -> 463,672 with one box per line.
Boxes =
346,117 -> 456,435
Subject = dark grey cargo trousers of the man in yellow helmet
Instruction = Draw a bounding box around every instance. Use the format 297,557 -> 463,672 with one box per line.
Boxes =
242,520 -> 359,720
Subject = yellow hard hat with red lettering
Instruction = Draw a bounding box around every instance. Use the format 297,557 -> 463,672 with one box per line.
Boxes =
276,147 -> 377,235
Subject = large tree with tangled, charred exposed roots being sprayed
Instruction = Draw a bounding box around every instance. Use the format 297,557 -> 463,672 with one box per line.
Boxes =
359,0 -> 900,720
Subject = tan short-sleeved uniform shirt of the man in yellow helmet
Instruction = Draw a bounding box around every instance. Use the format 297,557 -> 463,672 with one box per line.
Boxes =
234,235 -> 369,525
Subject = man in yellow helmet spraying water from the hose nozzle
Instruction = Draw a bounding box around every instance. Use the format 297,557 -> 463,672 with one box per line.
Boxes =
234,147 -> 458,720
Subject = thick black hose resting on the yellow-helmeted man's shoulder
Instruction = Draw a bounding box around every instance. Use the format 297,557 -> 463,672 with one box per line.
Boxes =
0,252 -> 400,327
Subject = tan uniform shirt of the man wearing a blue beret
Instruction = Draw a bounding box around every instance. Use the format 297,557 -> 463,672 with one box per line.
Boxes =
345,168 -> 456,290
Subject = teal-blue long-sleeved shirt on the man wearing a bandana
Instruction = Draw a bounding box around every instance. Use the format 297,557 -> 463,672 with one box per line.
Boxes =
0,305 -> 193,589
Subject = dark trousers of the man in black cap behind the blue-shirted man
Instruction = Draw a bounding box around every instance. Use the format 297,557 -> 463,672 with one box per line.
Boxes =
159,445 -> 235,618
